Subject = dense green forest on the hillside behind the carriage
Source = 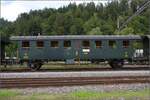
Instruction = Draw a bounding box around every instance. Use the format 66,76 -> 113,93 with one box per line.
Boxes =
0,0 -> 150,36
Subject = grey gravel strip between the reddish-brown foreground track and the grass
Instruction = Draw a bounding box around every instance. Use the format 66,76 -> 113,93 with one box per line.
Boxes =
5,84 -> 150,95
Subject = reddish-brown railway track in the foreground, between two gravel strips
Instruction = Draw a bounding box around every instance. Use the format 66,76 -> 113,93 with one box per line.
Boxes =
0,76 -> 150,88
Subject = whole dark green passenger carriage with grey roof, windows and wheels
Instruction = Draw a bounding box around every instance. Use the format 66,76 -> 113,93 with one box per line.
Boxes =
10,35 -> 150,70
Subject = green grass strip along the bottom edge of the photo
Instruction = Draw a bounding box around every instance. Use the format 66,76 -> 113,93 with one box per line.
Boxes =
0,88 -> 150,100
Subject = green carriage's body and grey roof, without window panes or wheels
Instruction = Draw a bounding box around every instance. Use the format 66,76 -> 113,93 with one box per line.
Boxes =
11,35 -> 141,61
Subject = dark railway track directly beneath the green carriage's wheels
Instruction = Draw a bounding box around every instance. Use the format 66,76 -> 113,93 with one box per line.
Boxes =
0,67 -> 150,73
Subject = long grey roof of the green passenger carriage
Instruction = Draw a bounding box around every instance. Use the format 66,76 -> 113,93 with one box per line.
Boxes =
10,35 -> 141,41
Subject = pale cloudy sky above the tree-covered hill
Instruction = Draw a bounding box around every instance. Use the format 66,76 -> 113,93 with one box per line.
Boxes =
0,0 -> 111,21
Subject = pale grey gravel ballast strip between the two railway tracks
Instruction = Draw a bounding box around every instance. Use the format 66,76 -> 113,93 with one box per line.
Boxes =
0,71 -> 150,78
